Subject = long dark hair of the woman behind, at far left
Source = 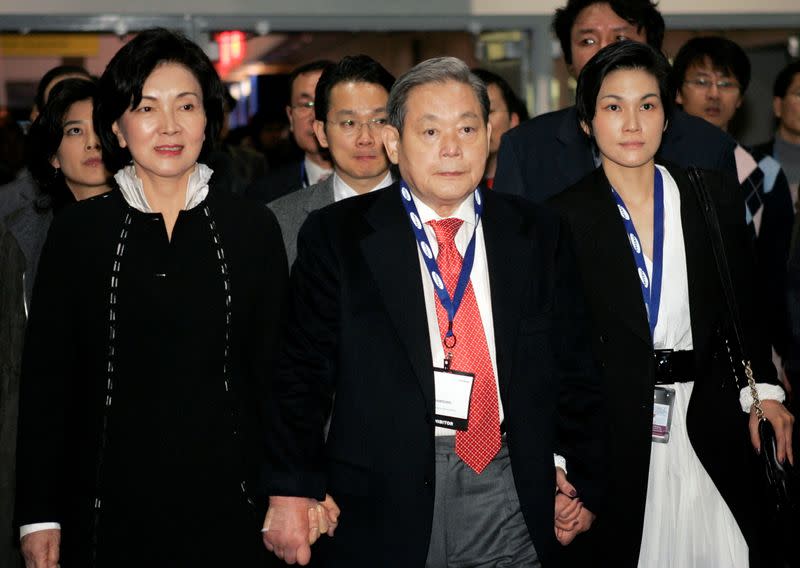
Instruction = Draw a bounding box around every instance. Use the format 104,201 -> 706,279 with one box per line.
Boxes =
26,79 -> 97,203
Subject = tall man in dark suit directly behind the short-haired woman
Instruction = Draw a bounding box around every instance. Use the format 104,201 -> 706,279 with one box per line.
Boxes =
495,0 -> 736,202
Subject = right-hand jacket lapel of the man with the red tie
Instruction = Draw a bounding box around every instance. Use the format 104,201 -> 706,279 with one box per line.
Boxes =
481,191 -> 534,400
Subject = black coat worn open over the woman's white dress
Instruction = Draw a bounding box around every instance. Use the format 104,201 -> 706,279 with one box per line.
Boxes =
549,165 -> 776,567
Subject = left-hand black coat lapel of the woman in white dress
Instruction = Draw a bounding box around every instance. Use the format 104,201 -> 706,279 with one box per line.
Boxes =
576,168 -> 653,346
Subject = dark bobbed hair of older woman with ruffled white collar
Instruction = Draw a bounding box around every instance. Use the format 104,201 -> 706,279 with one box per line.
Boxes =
99,28 -> 225,173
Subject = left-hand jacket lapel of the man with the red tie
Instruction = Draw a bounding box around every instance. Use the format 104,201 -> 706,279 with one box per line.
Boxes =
361,183 -> 434,415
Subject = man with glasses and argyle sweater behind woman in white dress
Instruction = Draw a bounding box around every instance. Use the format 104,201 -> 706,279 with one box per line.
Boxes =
671,36 -> 794,404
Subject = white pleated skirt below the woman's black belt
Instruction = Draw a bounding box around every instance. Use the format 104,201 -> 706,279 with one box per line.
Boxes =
639,382 -> 749,568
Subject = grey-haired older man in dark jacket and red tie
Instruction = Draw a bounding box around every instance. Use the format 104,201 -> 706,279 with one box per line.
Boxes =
265,57 -> 603,568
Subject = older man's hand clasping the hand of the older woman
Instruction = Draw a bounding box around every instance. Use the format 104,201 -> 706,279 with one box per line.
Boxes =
261,497 -> 314,566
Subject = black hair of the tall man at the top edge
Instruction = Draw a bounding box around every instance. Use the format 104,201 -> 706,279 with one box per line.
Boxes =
553,0 -> 664,65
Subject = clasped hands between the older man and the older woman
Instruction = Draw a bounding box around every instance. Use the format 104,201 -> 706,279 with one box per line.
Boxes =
261,495 -> 340,566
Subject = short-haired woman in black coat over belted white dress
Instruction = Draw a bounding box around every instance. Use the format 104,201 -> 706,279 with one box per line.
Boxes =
551,42 -> 793,568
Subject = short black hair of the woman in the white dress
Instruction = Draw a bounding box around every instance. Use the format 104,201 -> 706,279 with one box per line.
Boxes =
575,41 -> 673,135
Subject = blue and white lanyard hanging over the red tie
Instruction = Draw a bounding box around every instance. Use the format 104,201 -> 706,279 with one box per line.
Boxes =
400,180 -> 483,348
